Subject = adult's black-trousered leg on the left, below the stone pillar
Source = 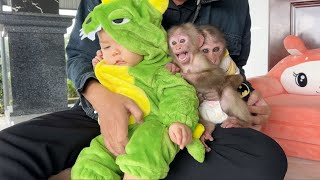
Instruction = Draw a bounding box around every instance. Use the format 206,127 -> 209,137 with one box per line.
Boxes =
0,107 -> 100,180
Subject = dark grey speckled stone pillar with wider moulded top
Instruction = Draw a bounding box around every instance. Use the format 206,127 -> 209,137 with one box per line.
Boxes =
0,12 -> 73,117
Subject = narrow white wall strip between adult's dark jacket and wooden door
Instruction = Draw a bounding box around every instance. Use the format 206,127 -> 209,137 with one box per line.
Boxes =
244,0 -> 269,77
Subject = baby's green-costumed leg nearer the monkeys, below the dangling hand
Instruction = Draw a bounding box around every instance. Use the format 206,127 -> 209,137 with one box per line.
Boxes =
116,120 -> 178,179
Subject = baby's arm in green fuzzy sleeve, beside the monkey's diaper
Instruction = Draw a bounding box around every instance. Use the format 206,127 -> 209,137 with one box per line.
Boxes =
153,68 -> 199,131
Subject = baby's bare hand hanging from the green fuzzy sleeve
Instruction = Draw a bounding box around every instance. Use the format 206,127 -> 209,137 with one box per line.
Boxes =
169,122 -> 192,149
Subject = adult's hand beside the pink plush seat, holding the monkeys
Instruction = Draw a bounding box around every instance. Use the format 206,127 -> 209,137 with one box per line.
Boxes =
247,90 -> 271,125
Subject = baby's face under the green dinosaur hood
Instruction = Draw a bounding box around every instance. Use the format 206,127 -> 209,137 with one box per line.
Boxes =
98,30 -> 143,66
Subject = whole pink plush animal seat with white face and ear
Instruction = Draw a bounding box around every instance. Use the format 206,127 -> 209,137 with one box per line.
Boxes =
249,35 -> 320,160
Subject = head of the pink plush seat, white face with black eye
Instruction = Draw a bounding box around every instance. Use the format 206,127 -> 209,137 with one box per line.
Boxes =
268,35 -> 320,95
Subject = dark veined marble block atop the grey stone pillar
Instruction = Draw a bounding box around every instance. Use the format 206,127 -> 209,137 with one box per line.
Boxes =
11,0 -> 59,14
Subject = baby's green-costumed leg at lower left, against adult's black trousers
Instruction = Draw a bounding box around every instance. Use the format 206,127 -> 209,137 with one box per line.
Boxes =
71,135 -> 123,179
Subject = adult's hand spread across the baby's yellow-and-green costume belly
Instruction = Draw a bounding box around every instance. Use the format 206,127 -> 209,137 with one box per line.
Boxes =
83,80 -> 143,156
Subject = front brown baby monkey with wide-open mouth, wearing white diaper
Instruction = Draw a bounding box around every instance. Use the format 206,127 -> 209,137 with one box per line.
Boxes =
168,23 -> 252,151
